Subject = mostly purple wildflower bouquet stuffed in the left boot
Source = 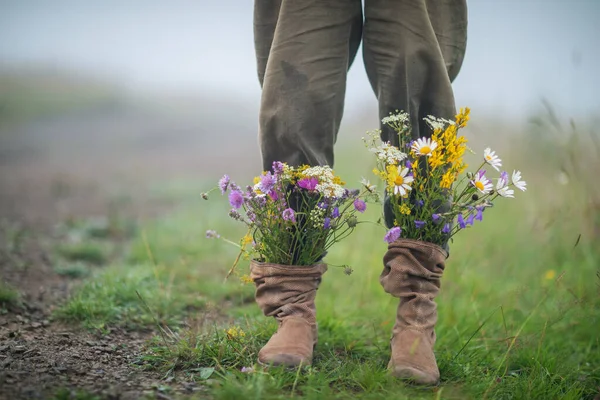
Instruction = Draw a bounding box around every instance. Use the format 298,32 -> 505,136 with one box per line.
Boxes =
207,162 -> 376,274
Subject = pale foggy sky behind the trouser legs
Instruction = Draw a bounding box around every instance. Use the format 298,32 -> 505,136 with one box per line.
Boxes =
0,0 -> 600,119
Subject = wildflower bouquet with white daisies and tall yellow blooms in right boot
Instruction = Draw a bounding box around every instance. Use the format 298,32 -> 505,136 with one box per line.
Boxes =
364,108 -> 526,246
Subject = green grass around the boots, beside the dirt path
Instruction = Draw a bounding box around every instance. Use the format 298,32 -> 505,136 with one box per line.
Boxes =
59,115 -> 600,399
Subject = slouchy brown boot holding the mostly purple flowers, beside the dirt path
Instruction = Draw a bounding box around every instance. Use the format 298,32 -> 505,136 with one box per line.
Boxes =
250,261 -> 327,367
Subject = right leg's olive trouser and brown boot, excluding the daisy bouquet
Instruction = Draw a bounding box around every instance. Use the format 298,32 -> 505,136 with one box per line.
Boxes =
363,0 -> 467,384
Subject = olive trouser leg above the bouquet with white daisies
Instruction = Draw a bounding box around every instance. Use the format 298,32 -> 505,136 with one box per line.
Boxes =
363,0 -> 467,144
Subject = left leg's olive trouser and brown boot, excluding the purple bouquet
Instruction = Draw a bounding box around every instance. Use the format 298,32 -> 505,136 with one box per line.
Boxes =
251,0 -> 362,366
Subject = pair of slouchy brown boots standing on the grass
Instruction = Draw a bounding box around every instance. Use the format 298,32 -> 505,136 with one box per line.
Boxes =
251,239 -> 448,385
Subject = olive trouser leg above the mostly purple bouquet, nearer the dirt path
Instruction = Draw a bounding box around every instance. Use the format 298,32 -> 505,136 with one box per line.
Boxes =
254,0 -> 362,170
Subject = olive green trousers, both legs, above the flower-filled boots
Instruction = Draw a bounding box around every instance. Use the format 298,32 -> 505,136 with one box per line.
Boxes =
254,0 -> 467,170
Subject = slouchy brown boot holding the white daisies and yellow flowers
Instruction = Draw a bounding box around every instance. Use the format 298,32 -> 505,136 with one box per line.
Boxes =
379,239 -> 448,385
